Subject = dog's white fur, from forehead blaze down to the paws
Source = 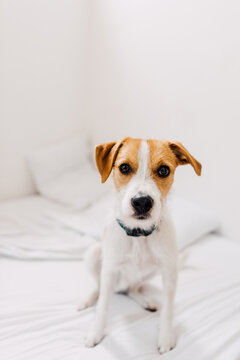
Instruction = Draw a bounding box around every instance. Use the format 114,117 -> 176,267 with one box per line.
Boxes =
79,141 -> 178,354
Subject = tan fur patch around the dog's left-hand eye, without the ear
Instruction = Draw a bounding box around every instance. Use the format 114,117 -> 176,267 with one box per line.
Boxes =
113,138 -> 141,191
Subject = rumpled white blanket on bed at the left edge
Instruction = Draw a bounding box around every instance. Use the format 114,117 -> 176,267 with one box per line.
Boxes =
0,196 -> 96,260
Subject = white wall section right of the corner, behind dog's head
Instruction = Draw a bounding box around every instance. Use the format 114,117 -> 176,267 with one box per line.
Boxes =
87,0 -> 240,236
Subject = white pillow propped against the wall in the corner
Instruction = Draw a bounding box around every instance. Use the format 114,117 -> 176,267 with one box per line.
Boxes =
28,136 -> 105,209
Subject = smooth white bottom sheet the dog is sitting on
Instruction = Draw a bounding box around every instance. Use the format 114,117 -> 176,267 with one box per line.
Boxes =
0,235 -> 240,360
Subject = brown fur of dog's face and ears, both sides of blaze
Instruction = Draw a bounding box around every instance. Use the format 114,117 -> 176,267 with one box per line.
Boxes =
96,138 -> 202,197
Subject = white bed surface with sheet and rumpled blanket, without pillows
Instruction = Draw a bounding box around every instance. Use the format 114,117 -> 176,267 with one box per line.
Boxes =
0,196 -> 240,360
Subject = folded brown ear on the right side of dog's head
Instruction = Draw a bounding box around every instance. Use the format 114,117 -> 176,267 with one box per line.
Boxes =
169,142 -> 202,176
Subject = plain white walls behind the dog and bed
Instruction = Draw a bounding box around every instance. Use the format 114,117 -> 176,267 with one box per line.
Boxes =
0,0 -> 240,237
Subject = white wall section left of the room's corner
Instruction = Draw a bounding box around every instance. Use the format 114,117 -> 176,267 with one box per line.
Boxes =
0,0 -> 88,200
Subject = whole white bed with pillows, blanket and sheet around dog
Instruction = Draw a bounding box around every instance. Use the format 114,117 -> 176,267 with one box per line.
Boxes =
0,136 -> 240,360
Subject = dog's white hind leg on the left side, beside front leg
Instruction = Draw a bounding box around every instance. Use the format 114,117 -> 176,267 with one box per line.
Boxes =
78,244 -> 102,311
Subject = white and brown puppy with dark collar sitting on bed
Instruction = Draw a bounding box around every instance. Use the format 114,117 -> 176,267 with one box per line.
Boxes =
79,138 -> 201,354
